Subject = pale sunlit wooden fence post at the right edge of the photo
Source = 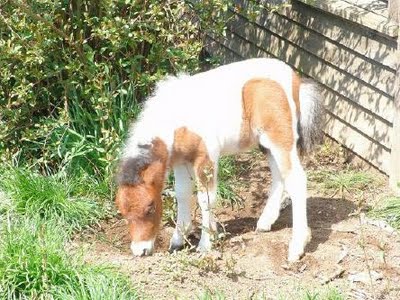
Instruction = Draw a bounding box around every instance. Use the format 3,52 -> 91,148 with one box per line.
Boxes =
389,0 -> 400,194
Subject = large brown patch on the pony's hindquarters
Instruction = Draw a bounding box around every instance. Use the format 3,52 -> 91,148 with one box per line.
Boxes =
242,78 -> 294,176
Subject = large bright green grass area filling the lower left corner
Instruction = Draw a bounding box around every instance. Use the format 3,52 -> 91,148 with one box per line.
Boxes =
0,167 -> 138,300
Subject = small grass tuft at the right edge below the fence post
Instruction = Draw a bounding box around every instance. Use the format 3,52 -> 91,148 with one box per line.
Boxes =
369,197 -> 400,230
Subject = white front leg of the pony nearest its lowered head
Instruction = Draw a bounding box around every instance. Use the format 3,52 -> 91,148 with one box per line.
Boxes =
169,165 -> 193,252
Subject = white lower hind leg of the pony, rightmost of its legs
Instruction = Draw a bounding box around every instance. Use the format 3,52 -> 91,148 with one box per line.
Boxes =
285,153 -> 311,261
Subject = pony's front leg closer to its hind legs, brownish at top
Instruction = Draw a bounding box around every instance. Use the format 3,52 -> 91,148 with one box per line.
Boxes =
196,161 -> 218,252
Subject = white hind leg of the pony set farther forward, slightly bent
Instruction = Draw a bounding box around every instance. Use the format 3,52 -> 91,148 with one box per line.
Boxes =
257,154 -> 283,231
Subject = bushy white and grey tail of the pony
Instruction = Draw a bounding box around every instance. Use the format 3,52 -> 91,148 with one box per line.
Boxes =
297,78 -> 323,155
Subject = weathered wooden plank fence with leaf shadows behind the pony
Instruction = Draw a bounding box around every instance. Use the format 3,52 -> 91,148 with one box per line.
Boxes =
207,0 -> 400,189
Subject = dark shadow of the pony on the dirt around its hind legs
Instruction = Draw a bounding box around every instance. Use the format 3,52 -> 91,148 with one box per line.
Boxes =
224,197 -> 356,252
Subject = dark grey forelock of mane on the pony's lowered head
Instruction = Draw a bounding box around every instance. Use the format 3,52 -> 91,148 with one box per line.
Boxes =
116,144 -> 155,185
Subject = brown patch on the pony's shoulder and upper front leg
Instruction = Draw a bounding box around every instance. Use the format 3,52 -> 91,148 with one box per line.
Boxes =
170,127 -> 214,188
